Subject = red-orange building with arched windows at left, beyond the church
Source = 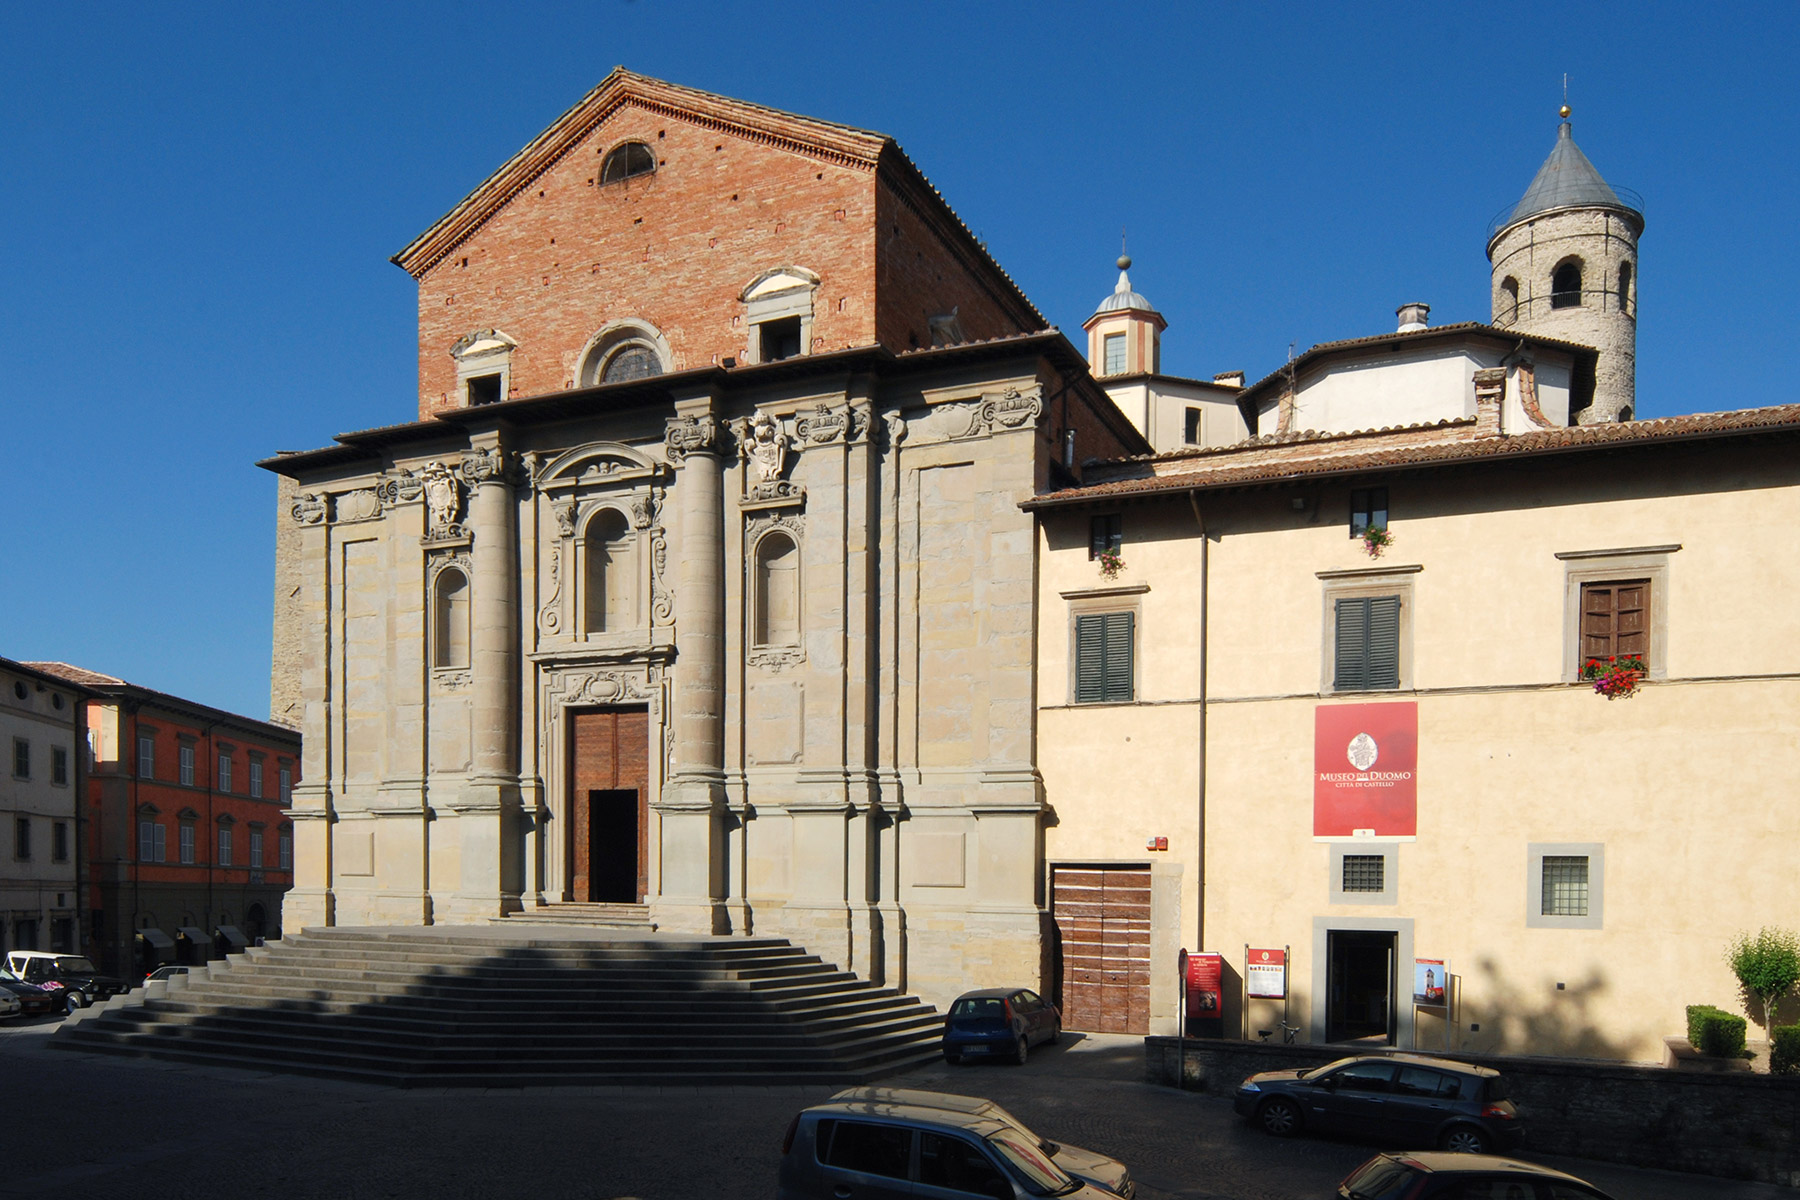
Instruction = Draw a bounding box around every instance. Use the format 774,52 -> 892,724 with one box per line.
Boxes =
31,662 -> 301,979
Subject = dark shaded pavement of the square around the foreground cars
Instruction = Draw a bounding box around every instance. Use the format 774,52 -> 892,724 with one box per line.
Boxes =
0,1018 -> 1795,1200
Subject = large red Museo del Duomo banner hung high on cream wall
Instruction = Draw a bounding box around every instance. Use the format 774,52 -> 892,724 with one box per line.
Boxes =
1312,700 -> 1418,838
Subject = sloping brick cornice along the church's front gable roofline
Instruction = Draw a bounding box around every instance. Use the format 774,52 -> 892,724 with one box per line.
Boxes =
392,67 -> 893,277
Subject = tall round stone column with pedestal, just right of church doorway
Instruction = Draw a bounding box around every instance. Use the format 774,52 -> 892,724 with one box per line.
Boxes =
652,394 -> 733,934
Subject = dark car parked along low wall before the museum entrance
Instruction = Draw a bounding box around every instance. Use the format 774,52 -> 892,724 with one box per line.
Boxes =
1235,1054 -> 1535,1151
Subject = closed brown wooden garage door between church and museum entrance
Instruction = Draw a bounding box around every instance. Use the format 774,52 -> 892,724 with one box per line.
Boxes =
1049,865 -> 1150,1033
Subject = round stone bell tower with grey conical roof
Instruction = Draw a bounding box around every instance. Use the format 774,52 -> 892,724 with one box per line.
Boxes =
1487,104 -> 1643,425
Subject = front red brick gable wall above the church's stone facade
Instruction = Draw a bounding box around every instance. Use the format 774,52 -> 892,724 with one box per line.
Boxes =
419,104 -> 875,419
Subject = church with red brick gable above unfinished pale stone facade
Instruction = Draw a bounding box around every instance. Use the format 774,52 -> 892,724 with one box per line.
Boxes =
265,70 -> 1148,1000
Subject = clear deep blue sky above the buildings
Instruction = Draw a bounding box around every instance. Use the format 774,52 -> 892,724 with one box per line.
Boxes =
0,0 -> 1800,716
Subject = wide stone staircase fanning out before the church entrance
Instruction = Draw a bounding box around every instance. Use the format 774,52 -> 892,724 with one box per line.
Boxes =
50,925 -> 943,1087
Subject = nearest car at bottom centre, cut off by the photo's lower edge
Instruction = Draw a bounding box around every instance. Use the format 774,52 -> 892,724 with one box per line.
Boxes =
776,1101 -> 1112,1200
